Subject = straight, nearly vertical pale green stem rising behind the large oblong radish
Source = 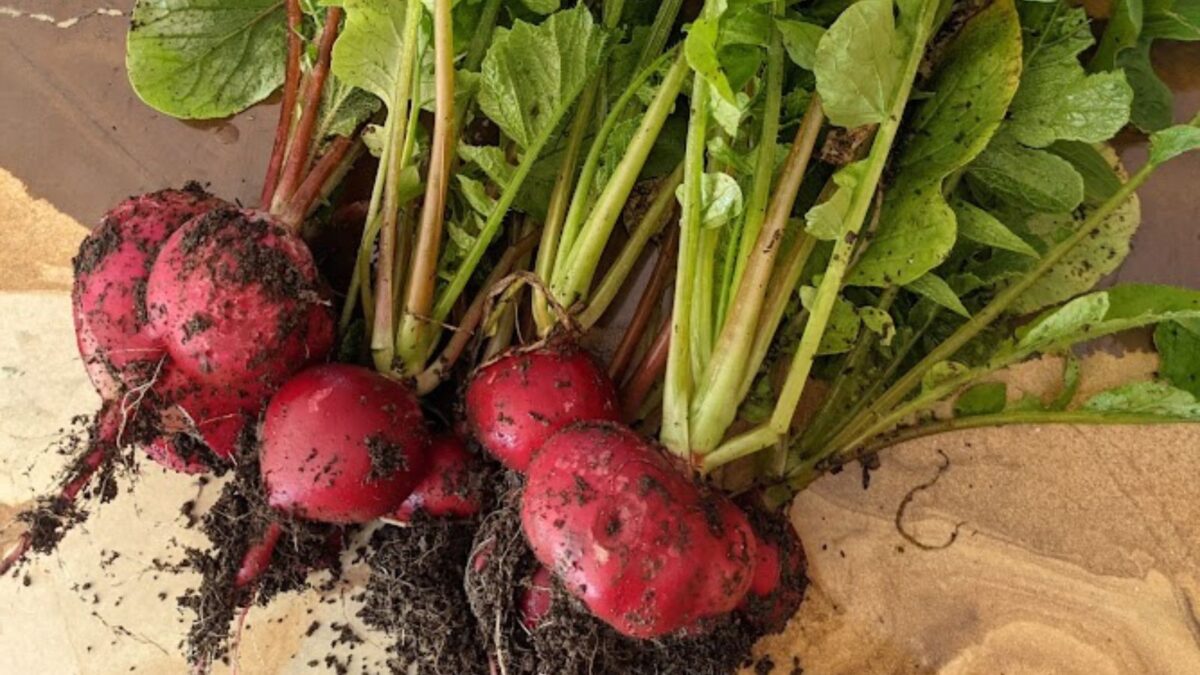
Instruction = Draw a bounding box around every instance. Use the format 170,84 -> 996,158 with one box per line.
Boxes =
659,77 -> 709,456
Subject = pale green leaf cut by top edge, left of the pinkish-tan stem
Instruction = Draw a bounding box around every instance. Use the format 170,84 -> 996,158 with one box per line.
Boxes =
330,0 -> 417,109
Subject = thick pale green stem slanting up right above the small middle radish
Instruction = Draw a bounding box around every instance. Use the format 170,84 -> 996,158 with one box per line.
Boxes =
551,54 -> 688,307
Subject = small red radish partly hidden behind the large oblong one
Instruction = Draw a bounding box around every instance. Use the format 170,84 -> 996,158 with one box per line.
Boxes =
464,340 -> 619,471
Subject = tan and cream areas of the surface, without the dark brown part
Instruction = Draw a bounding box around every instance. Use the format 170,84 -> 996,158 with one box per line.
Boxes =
0,172 -> 1200,675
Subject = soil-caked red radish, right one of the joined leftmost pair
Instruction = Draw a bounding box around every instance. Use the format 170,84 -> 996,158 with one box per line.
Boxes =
146,208 -> 334,399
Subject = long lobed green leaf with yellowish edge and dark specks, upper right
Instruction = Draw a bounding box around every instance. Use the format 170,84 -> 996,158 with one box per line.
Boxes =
848,0 -> 1021,286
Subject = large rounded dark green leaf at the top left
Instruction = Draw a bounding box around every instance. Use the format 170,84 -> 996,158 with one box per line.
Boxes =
125,0 -> 287,119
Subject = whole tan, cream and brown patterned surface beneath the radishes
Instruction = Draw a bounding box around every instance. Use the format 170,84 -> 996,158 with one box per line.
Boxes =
0,0 -> 1200,675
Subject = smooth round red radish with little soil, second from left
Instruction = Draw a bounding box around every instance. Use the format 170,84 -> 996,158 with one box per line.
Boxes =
259,364 -> 430,522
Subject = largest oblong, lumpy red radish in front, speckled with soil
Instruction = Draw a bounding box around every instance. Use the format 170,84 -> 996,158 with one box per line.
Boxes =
521,422 -> 756,638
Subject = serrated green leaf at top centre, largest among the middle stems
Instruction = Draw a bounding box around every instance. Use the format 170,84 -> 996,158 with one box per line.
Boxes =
479,6 -> 606,148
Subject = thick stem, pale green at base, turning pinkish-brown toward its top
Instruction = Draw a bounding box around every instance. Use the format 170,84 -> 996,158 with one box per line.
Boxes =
689,96 -> 824,453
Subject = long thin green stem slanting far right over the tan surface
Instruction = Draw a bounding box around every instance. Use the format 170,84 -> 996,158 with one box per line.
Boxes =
828,157 -> 1157,452
